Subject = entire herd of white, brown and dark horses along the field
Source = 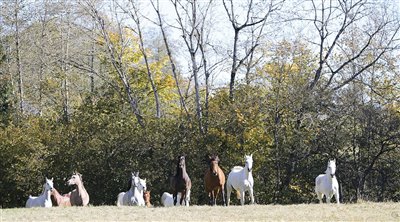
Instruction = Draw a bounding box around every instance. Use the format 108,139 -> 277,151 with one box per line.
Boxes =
26,154 -> 339,207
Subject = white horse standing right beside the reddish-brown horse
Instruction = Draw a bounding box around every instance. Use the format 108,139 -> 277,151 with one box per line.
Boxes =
226,154 -> 254,206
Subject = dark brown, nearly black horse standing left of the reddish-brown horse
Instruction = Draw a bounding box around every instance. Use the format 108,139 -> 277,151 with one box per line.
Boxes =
170,155 -> 192,206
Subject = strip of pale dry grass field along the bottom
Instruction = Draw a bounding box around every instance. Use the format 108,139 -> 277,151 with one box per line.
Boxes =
0,203 -> 400,221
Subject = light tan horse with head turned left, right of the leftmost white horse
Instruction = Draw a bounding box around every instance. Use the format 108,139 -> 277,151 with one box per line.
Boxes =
68,172 -> 89,206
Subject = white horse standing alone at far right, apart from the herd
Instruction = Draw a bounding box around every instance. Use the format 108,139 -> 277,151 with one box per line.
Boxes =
315,160 -> 339,204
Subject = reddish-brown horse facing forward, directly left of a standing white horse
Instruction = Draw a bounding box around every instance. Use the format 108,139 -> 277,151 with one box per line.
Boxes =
204,155 -> 225,206
